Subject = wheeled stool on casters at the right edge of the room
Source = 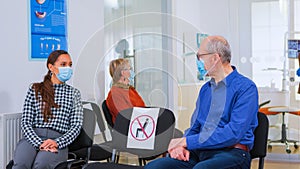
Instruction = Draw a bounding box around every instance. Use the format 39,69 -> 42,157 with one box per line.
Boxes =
268,107 -> 299,153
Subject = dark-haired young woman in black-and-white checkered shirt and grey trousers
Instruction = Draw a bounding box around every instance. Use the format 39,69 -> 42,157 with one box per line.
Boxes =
13,50 -> 83,169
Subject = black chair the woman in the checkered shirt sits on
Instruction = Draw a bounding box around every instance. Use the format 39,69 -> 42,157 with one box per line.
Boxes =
55,105 -> 96,169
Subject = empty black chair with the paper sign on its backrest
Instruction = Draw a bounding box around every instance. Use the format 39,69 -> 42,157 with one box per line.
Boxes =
83,108 -> 175,168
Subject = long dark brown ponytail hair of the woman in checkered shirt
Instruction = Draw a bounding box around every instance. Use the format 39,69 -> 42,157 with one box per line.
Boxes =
33,50 -> 69,122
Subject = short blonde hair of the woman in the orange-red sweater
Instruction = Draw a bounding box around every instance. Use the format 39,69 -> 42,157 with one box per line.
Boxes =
109,58 -> 130,83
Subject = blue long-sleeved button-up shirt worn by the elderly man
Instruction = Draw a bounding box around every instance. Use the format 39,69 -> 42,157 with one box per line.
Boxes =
185,67 -> 258,150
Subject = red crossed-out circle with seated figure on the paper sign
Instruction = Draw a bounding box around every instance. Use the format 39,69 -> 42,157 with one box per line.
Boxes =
130,115 -> 155,141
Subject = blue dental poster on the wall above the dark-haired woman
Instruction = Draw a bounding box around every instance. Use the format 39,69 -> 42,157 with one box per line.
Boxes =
30,0 -> 68,59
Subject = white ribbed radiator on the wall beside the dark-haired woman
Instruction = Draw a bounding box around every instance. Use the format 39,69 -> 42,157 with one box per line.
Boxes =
0,113 -> 22,168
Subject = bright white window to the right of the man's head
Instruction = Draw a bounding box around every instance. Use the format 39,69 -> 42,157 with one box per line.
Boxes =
251,1 -> 288,90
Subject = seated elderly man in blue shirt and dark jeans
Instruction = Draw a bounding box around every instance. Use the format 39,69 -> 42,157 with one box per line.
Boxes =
145,36 -> 258,169
